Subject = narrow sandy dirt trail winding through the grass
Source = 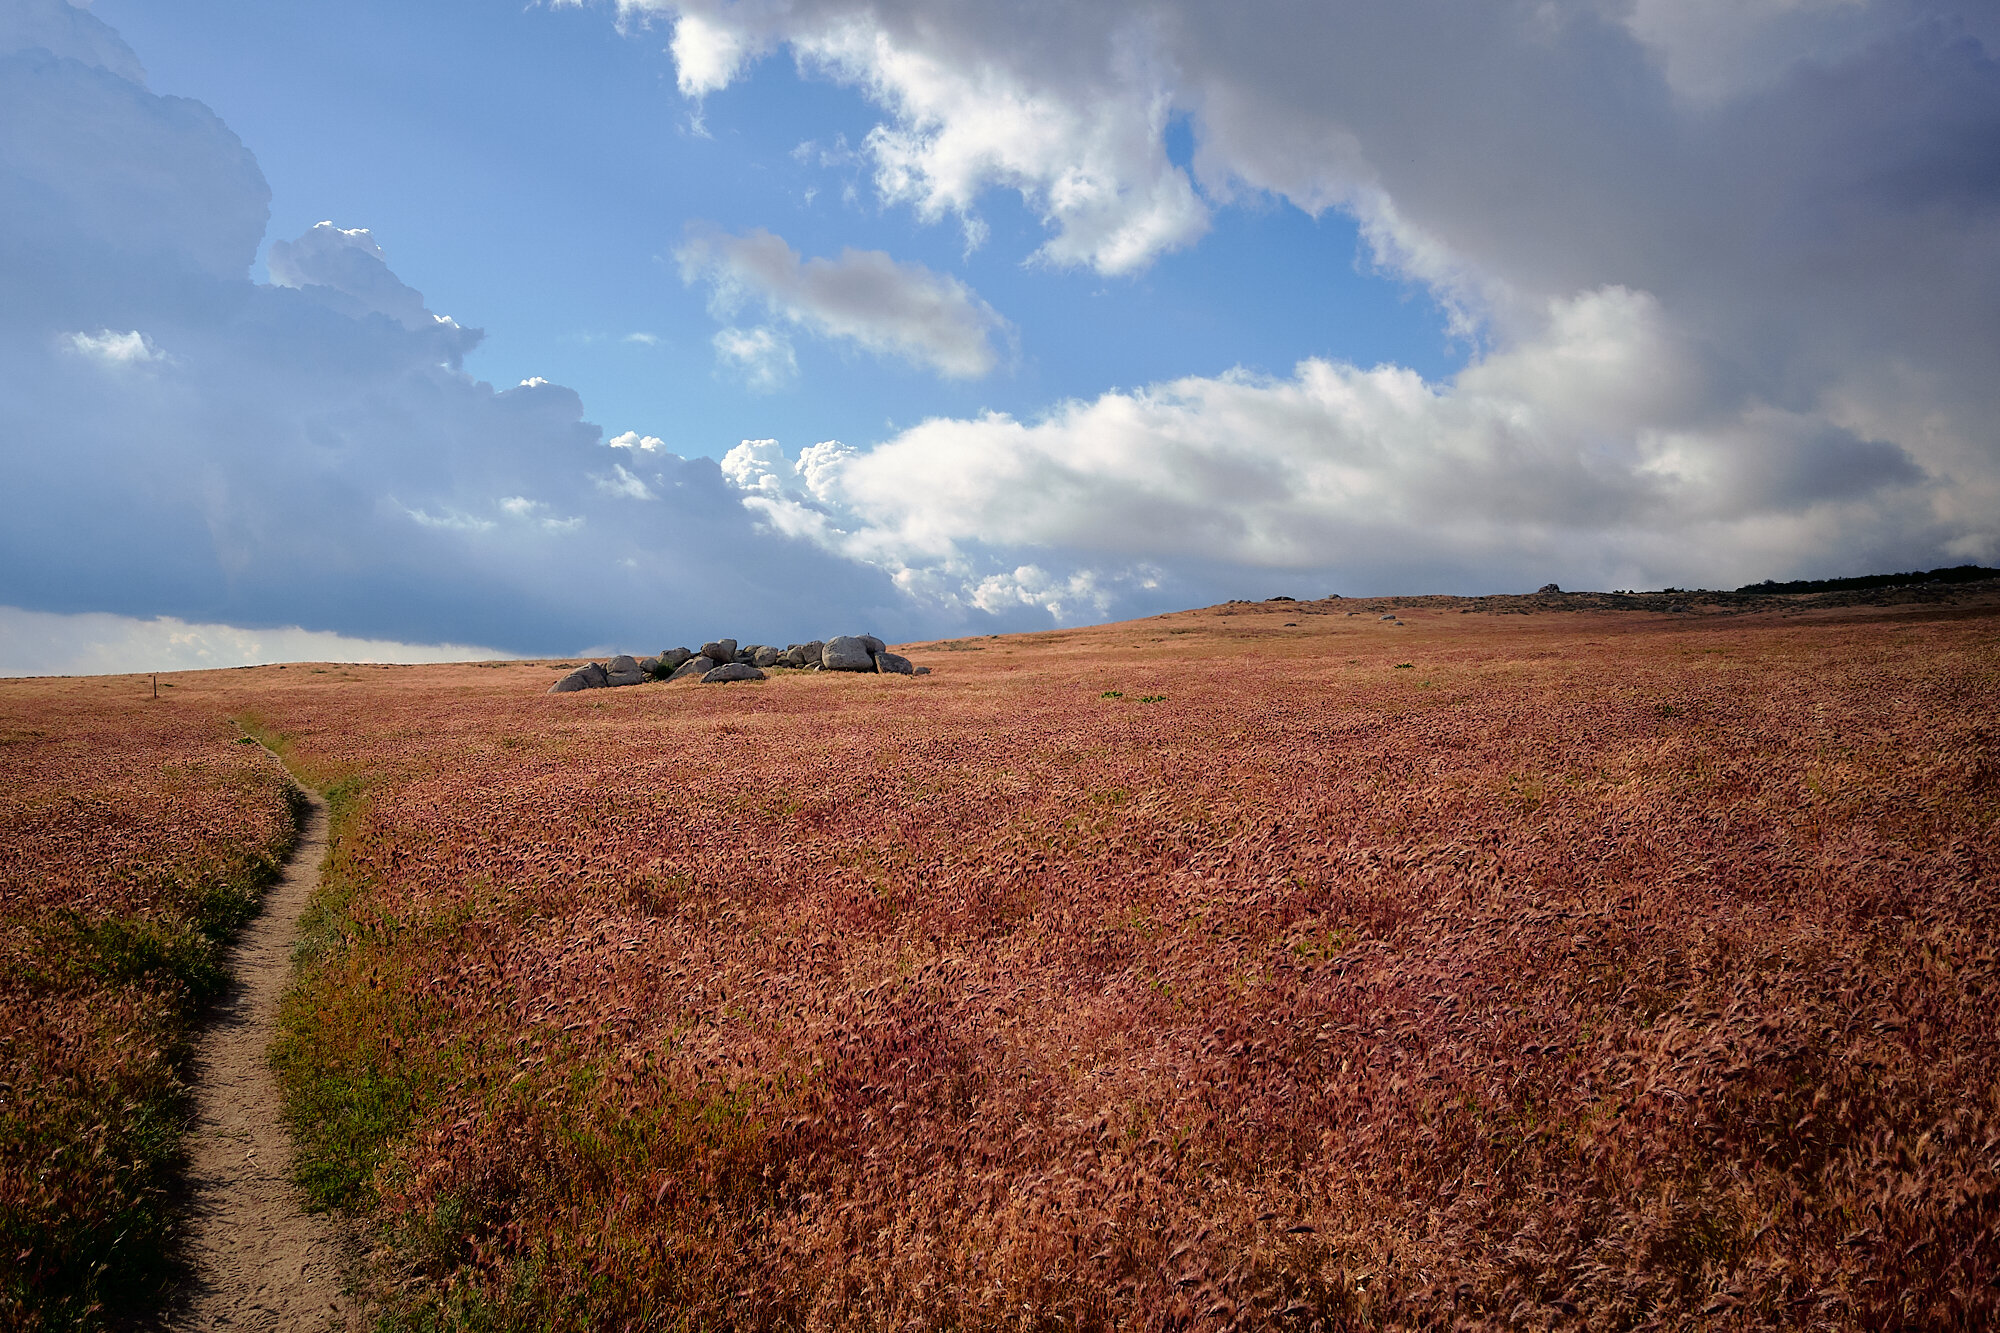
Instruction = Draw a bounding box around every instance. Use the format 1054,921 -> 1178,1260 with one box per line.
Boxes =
166,757 -> 362,1333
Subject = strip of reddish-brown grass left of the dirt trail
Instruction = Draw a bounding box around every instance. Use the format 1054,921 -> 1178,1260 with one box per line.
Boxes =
0,679 -> 294,1329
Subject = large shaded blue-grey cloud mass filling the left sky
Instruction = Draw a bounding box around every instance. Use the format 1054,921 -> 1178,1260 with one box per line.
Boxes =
0,0 -> 940,671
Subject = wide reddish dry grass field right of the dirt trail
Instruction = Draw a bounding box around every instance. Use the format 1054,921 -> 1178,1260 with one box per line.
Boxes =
0,596 -> 2000,1329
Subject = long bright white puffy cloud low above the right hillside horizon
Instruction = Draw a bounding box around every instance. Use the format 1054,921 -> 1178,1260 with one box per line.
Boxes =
724,288 -> 1950,618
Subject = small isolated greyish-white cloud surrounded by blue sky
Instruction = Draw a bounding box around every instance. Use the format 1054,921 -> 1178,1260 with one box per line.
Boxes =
678,228 -> 1008,378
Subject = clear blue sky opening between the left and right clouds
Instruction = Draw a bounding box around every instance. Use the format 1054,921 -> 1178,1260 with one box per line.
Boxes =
92,0 -> 1468,456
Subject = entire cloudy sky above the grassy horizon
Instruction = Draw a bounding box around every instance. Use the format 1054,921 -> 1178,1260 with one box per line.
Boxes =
0,0 -> 2000,675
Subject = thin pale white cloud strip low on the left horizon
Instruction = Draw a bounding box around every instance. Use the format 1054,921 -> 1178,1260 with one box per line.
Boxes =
0,606 -> 508,677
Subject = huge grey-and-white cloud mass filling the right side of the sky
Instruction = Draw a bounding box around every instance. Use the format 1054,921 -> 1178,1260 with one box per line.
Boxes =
620,0 -> 2000,588
